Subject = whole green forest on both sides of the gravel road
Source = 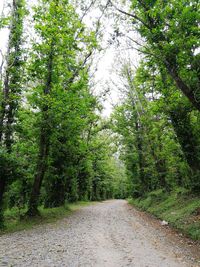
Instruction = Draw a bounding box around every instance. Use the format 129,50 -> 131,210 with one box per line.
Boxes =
0,0 -> 200,233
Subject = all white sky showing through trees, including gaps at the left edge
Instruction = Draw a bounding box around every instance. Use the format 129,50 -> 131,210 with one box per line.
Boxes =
0,0 -> 140,117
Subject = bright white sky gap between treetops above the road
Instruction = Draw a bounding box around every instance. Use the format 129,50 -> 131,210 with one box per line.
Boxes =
80,0 -> 141,117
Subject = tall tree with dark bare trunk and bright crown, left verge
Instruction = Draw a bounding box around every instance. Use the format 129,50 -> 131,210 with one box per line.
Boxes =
28,0 -> 95,216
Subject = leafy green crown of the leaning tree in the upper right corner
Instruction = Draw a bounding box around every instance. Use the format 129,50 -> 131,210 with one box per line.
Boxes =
110,0 -> 200,110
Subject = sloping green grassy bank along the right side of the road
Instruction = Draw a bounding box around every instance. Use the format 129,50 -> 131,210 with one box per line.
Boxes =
129,188 -> 200,240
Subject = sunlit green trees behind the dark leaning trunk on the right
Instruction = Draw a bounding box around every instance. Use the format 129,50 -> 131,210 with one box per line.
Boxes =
112,63 -> 191,196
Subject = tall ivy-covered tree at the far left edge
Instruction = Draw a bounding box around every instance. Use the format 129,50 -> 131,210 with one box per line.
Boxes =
0,0 -> 26,226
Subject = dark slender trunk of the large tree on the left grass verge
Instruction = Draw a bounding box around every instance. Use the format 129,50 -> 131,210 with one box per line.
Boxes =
27,41 -> 54,216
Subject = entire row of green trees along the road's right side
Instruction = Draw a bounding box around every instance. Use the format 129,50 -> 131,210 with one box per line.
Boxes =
110,0 -> 200,197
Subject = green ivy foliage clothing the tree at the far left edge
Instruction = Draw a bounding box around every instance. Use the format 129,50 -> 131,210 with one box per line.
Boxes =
0,0 -> 26,226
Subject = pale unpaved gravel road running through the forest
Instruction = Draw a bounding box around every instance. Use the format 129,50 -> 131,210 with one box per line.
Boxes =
0,200 -> 200,267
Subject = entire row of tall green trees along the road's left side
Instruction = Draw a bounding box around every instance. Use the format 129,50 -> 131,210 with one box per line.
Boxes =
0,0 -> 127,228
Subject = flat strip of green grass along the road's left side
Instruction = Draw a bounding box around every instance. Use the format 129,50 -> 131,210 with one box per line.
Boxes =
0,201 -> 94,235
